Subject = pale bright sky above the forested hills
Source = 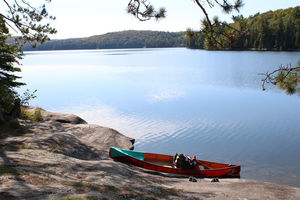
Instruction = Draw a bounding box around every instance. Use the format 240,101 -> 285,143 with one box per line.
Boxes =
24,0 -> 300,38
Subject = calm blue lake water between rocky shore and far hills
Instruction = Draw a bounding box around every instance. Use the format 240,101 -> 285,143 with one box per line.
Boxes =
21,48 -> 300,187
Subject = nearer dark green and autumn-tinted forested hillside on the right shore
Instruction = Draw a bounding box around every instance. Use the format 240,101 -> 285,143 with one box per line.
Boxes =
187,6 -> 300,50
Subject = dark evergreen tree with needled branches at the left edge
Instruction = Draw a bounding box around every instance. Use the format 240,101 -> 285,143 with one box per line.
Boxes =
0,0 -> 56,120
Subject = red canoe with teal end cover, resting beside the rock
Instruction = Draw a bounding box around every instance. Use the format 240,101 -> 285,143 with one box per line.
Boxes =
109,147 -> 241,177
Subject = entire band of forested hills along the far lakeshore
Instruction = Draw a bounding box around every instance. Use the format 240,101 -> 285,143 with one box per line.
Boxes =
23,6 -> 300,50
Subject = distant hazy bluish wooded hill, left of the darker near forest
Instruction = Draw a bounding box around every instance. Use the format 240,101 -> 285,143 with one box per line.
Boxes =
23,31 -> 186,51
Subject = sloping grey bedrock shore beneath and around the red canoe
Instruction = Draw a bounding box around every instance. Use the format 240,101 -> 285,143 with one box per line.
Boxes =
0,107 -> 300,200
